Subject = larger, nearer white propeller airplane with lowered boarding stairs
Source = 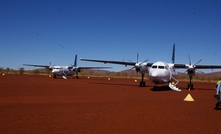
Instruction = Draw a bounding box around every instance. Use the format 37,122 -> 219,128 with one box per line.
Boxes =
80,44 -> 221,91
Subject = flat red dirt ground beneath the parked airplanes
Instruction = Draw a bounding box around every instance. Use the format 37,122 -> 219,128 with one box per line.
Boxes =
0,75 -> 221,134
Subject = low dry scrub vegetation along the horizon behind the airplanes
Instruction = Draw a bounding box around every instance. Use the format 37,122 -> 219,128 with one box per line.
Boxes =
0,68 -> 221,82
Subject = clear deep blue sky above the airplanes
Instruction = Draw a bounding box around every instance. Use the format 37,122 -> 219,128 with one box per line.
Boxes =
0,0 -> 221,71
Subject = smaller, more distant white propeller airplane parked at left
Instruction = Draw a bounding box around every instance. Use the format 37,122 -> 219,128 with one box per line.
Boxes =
23,55 -> 111,79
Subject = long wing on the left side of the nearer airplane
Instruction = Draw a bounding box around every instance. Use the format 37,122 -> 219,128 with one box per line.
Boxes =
80,58 -> 136,66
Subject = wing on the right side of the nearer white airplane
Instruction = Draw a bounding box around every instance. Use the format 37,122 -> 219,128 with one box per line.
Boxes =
174,64 -> 221,69
